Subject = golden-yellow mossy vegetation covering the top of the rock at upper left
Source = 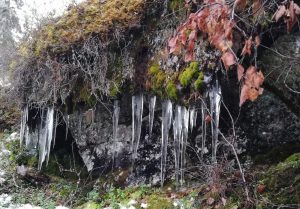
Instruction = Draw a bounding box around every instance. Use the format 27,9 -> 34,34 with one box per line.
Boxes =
33,0 -> 145,56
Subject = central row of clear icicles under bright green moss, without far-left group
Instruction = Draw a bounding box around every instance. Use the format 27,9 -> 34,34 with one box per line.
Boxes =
113,81 -> 221,185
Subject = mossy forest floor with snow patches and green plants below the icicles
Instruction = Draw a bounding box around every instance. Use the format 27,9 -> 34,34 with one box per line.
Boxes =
0,133 -> 300,209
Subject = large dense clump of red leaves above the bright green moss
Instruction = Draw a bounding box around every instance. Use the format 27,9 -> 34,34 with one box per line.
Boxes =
168,0 -> 235,62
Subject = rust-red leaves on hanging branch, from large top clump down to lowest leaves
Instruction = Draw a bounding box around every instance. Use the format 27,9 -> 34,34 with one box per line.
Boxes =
168,0 -> 270,105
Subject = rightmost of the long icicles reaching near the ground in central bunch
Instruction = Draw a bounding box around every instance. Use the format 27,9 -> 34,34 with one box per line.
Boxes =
180,107 -> 189,185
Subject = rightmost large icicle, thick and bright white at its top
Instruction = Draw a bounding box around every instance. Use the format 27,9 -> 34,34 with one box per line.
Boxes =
209,80 -> 221,163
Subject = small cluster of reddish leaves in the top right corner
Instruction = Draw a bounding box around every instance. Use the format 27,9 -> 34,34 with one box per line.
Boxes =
272,1 -> 300,32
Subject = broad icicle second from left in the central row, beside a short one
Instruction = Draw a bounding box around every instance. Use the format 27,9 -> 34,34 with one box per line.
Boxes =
131,94 -> 144,165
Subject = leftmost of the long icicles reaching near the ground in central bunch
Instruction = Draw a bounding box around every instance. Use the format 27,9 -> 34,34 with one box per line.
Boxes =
161,100 -> 173,186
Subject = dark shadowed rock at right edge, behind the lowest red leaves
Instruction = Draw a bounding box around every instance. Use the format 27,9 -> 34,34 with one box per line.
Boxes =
239,34 -> 300,152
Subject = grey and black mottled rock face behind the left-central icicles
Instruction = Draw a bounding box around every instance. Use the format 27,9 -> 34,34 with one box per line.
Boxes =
69,95 -> 173,184
